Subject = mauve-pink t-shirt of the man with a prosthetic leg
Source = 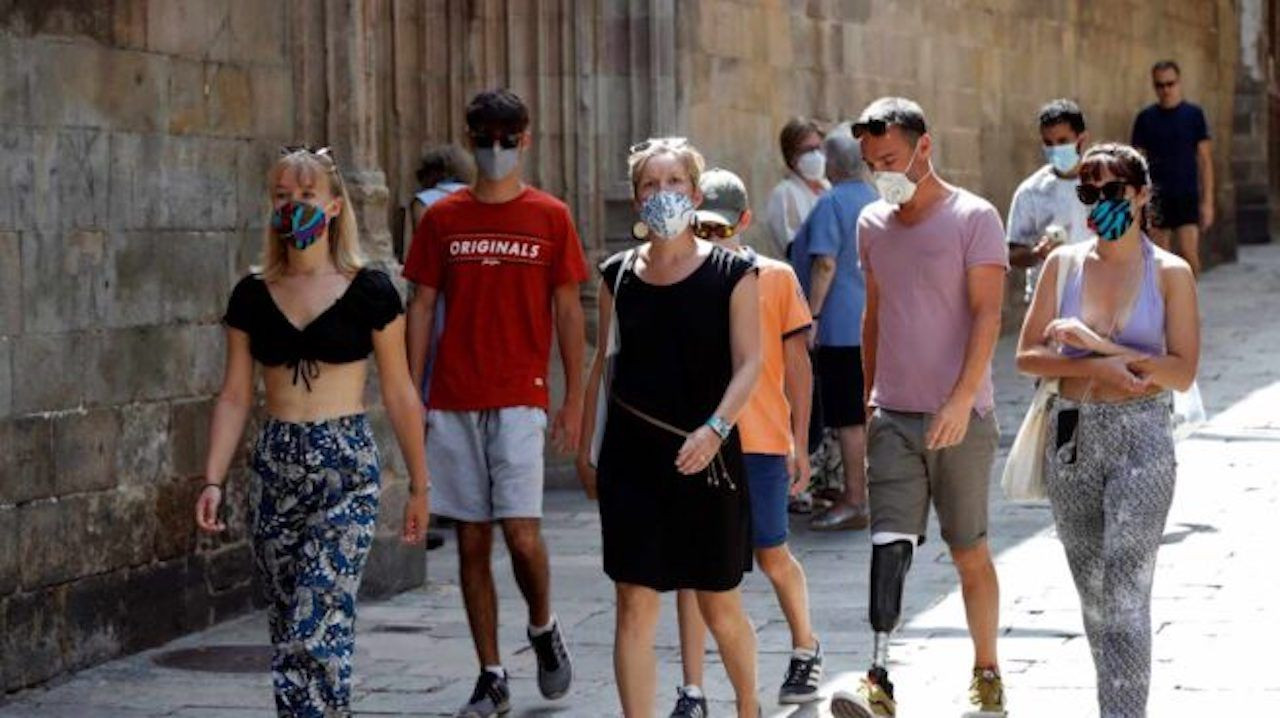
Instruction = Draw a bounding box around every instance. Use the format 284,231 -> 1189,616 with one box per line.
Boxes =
858,188 -> 1009,415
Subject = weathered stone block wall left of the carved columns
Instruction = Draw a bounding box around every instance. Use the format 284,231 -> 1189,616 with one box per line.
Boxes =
0,0 -> 424,690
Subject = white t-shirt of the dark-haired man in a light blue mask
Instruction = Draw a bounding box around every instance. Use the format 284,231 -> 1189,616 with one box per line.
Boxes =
1006,165 -> 1093,302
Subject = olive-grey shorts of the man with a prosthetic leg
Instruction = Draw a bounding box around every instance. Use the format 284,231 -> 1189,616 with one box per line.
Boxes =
867,408 -> 1000,548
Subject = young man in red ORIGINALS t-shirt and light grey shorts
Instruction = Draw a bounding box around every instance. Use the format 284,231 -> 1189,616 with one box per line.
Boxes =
404,90 -> 588,718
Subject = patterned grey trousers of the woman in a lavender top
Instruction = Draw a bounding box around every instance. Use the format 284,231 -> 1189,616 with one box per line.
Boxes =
1044,394 -> 1176,718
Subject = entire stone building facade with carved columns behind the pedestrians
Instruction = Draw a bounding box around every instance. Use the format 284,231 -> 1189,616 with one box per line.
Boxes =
0,0 -> 1280,691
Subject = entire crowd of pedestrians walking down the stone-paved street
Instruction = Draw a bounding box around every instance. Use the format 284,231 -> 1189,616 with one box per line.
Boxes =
196,61 -> 1213,718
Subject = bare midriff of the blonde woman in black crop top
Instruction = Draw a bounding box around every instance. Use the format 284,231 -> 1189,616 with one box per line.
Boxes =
262,360 -> 369,422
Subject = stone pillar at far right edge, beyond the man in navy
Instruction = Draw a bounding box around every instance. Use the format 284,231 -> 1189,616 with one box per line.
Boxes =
1229,0 -> 1276,244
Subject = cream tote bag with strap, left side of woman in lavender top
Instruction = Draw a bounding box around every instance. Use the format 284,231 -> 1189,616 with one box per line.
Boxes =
1000,243 -> 1089,502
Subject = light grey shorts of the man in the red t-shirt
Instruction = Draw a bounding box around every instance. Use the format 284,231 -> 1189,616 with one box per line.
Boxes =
426,407 -> 547,522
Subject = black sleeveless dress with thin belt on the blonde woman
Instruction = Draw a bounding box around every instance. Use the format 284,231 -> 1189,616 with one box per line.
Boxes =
596,247 -> 755,591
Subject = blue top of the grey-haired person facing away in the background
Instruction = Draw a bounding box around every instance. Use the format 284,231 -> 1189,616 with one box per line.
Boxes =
788,179 -> 878,347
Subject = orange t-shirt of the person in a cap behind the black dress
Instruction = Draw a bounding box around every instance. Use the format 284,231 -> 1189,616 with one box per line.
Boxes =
737,250 -> 813,456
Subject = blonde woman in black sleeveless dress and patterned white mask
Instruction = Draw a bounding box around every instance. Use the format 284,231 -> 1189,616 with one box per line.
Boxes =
579,138 -> 760,718
